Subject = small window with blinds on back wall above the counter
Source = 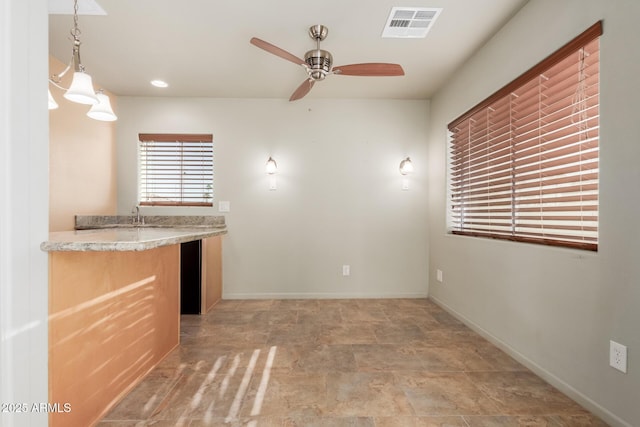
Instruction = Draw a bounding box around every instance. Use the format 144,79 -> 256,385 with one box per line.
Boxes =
139,133 -> 213,206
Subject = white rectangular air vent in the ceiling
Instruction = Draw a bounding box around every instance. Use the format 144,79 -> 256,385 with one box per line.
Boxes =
382,7 -> 442,39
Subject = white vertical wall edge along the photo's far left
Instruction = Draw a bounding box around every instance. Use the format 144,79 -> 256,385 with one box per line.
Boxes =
0,0 -> 49,427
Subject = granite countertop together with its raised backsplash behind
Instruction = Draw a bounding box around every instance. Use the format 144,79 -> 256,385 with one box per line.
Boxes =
40,216 -> 227,252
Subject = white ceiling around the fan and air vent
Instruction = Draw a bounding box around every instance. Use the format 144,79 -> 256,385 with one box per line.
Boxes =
49,0 -> 527,99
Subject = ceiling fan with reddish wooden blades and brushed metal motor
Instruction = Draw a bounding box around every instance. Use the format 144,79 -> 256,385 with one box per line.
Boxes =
250,25 -> 404,101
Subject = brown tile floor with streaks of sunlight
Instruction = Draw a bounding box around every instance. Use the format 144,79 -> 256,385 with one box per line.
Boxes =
98,299 -> 606,427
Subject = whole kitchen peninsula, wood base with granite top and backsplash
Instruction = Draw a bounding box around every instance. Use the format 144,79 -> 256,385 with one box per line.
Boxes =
41,216 -> 227,426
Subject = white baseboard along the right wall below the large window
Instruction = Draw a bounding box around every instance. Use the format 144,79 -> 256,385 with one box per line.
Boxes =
429,296 -> 632,427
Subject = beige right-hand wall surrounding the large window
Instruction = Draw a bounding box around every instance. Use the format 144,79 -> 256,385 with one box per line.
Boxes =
428,0 -> 640,426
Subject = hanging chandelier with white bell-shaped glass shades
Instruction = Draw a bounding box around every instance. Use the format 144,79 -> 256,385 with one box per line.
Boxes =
49,0 -> 118,121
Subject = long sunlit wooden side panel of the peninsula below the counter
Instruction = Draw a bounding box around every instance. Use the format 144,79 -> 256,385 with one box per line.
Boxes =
49,245 -> 180,427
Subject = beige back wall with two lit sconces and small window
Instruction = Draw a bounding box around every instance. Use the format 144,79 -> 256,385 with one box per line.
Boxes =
118,97 -> 429,298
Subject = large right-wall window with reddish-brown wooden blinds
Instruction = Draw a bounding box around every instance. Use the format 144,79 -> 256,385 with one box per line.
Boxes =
448,22 -> 602,251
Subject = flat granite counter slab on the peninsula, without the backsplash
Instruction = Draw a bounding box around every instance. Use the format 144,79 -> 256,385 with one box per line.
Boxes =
40,226 -> 227,252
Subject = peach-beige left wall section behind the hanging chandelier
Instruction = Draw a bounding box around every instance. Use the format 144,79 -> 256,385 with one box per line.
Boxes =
49,57 -> 118,231
